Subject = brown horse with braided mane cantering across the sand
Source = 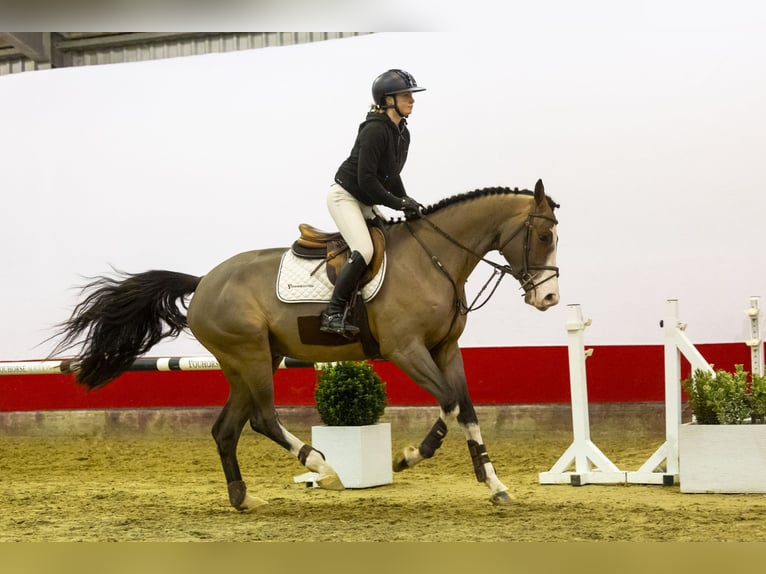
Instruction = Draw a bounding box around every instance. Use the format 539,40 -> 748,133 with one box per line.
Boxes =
51,180 -> 559,511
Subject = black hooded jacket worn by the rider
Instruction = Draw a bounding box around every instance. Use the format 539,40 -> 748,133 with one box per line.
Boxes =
335,112 -> 410,209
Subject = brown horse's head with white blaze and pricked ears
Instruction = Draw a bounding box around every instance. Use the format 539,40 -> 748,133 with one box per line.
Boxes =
500,180 -> 559,311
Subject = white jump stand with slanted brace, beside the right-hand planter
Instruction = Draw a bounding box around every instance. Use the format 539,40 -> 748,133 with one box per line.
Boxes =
627,299 -> 715,486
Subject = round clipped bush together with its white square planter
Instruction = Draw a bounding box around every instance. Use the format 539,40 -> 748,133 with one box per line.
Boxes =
311,361 -> 393,488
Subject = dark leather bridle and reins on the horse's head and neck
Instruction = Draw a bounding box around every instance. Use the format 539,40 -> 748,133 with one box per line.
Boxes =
405,200 -> 559,315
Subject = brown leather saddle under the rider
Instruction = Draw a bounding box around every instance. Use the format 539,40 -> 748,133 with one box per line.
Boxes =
291,223 -> 386,288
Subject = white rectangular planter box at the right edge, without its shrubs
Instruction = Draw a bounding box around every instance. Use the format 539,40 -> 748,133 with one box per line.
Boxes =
678,424 -> 766,493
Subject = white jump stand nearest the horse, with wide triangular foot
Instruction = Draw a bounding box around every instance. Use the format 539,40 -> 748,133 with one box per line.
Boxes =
539,305 -> 625,486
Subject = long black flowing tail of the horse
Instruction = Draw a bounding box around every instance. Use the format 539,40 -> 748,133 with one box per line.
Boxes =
51,271 -> 200,389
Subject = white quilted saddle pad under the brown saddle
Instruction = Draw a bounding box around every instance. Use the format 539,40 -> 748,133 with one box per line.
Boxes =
277,249 -> 386,303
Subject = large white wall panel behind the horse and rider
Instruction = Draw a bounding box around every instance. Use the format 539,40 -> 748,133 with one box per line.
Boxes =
0,21 -> 766,360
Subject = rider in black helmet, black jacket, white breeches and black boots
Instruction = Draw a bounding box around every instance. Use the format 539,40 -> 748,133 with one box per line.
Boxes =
320,70 -> 425,338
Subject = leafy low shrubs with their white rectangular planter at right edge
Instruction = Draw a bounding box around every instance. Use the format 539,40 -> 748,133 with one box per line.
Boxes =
679,365 -> 766,493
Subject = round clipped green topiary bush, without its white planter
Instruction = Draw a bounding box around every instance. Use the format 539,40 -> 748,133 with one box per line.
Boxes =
314,361 -> 387,426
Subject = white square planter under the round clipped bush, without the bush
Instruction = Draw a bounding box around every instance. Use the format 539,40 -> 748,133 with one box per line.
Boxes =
311,423 -> 394,488
